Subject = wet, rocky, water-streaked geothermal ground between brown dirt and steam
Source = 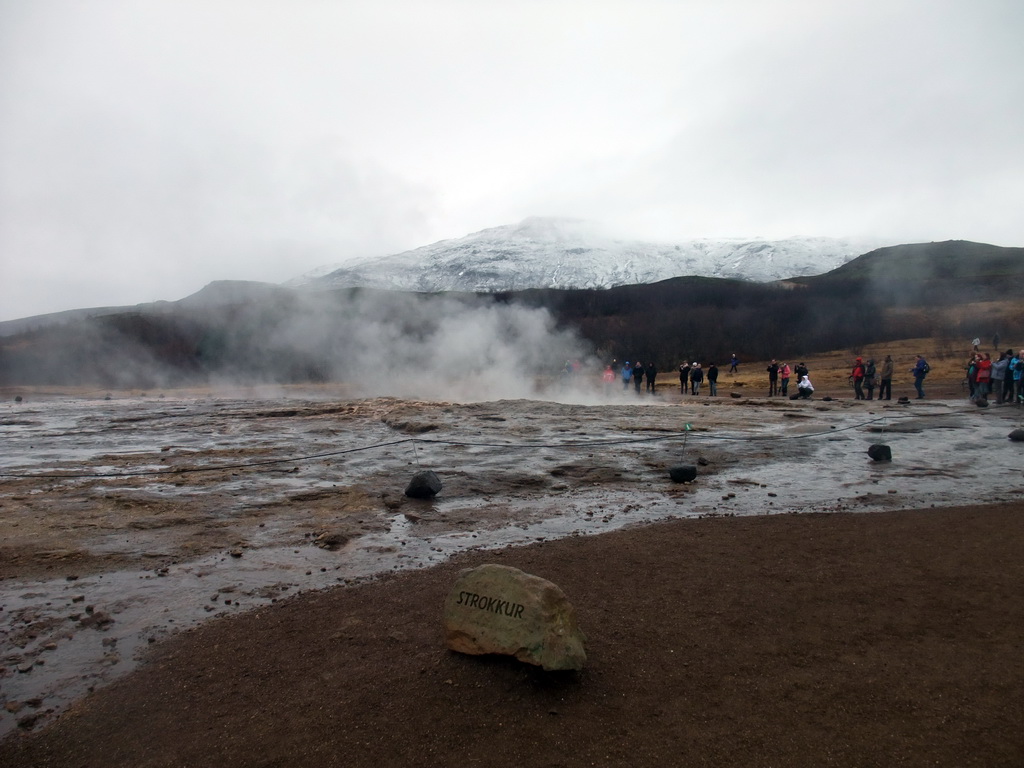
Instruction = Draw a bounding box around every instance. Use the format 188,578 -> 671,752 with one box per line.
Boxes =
0,389 -> 1024,735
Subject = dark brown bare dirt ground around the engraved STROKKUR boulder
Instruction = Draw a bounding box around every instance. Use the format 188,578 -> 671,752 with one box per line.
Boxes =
0,503 -> 1024,768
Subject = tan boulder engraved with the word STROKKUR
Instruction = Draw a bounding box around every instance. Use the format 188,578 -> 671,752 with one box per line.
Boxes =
444,564 -> 587,671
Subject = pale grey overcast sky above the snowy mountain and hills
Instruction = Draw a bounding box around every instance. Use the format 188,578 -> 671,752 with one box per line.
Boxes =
0,0 -> 1024,319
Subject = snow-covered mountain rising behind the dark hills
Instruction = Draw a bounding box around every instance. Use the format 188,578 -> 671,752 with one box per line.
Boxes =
294,217 -> 892,293
